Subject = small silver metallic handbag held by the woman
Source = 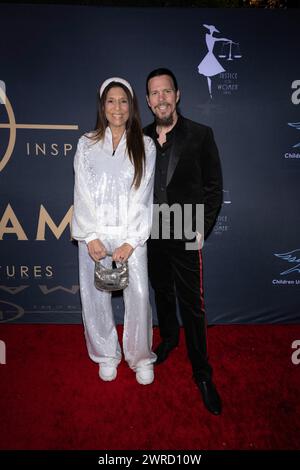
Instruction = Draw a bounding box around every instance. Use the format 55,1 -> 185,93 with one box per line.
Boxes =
94,253 -> 129,292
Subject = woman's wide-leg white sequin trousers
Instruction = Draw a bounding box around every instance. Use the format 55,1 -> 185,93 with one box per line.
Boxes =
78,240 -> 156,370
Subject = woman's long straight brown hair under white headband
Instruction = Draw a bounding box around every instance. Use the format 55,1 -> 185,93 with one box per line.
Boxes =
89,82 -> 146,189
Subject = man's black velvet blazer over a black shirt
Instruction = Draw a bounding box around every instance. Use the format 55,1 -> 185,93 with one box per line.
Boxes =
144,116 -> 222,237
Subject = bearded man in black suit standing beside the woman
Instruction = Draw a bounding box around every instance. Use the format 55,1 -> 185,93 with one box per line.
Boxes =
144,68 -> 222,415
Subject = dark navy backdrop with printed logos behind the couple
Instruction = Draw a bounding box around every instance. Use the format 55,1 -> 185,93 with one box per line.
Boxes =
0,5 -> 300,324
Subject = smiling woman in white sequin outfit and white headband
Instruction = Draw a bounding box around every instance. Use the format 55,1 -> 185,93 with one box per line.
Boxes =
72,77 -> 156,385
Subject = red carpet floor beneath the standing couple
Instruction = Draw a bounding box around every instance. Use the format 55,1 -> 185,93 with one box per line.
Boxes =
0,324 -> 300,450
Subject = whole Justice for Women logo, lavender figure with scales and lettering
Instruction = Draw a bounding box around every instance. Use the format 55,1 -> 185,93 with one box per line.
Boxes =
198,24 -> 242,99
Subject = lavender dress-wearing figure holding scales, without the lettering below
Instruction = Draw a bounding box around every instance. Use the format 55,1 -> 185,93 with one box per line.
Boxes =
198,24 -> 242,98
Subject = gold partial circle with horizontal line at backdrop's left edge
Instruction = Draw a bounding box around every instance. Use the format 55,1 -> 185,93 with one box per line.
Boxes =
0,80 -> 78,172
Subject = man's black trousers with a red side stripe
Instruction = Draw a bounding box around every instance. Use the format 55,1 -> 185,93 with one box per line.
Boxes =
148,239 -> 212,380
